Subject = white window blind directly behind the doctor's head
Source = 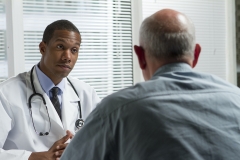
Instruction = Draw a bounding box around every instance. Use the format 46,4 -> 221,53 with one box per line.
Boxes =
23,0 -> 133,98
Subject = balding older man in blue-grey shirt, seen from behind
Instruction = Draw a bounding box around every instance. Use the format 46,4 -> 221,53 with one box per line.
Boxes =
61,9 -> 240,160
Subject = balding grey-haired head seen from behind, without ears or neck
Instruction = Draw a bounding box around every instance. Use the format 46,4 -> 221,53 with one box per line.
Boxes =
140,9 -> 195,61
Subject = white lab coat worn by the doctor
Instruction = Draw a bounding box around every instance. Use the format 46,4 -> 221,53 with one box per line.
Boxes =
0,67 -> 100,160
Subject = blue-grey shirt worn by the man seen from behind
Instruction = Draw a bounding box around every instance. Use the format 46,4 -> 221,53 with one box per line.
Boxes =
61,63 -> 240,160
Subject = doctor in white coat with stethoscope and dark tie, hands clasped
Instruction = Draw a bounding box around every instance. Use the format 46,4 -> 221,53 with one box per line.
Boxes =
0,20 -> 100,160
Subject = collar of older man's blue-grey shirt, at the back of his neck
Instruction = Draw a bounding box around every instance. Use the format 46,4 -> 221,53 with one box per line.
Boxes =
152,63 -> 192,79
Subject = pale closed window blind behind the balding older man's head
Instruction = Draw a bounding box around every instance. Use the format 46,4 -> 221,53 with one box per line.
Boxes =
142,0 -> 227,79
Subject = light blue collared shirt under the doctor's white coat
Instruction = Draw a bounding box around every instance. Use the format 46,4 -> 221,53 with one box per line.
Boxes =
35,65 -> 65,108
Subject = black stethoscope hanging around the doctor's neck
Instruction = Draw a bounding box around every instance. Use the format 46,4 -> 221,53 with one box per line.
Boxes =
28,66 -> 84,136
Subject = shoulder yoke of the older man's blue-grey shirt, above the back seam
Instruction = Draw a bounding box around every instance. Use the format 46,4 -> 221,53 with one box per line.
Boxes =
93,72 -> 240,115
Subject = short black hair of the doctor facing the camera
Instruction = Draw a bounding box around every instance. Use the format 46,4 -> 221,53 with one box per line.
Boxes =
42,19 -> 81,43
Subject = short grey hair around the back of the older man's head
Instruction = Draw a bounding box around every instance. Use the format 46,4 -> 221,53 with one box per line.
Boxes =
140,17 -> 195,60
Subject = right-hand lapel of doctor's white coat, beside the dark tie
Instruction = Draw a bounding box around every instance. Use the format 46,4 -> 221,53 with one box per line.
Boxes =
62,80 -> 80,133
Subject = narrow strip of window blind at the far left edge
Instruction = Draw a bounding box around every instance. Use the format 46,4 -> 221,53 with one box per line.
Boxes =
0,0 -> 8,82
